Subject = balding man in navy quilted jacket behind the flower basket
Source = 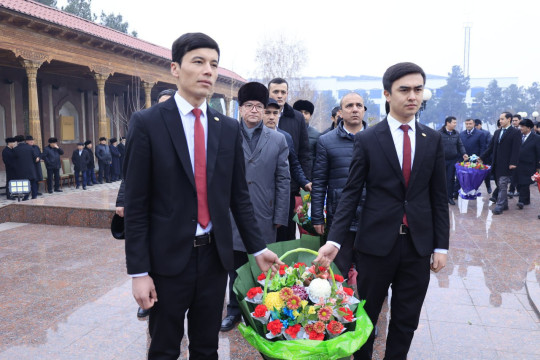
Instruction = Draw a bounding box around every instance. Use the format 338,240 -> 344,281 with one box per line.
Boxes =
311,92 -> 366,275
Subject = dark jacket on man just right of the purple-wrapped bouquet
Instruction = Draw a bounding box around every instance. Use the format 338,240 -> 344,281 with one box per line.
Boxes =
481,125 -> 521,178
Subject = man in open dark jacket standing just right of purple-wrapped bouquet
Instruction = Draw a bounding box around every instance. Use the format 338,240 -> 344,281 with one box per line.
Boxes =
481,112 -> 521,215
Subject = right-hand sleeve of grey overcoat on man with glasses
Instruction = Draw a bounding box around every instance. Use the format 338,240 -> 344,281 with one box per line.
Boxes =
274,136 -> 291,226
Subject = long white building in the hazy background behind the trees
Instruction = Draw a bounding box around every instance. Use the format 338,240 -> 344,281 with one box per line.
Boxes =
304,74 -> 518,116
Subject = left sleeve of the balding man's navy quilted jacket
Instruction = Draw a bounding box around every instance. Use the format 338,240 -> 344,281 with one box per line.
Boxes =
311,138 -> 328,225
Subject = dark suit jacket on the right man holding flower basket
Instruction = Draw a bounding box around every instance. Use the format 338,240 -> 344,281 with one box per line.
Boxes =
328,119 -> 449,256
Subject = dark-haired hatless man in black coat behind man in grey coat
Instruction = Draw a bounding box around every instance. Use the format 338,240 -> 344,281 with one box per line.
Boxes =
268,78 -> 311,241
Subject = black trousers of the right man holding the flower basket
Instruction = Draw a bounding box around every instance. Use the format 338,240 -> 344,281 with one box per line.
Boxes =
354,231 -> 431,360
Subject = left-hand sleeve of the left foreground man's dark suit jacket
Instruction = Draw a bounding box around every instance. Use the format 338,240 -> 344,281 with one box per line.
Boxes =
124,112 -> 152,274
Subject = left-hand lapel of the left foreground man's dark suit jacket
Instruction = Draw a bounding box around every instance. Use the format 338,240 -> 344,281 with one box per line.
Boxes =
161,97 -> 196,187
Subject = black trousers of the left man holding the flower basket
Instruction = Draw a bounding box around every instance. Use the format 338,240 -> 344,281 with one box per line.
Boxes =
148,244 -> 227,360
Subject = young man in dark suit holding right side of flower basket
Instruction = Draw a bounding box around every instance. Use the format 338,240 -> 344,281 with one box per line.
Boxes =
315,63 -> 449,359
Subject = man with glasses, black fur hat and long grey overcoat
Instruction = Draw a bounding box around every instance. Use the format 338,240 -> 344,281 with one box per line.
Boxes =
221,82 -> 291,331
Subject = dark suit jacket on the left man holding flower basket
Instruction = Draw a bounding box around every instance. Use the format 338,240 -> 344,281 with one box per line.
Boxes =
124,97 -> 266,275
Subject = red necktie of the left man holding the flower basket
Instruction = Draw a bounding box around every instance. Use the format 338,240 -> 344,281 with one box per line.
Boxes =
192,109 -> 210,229
